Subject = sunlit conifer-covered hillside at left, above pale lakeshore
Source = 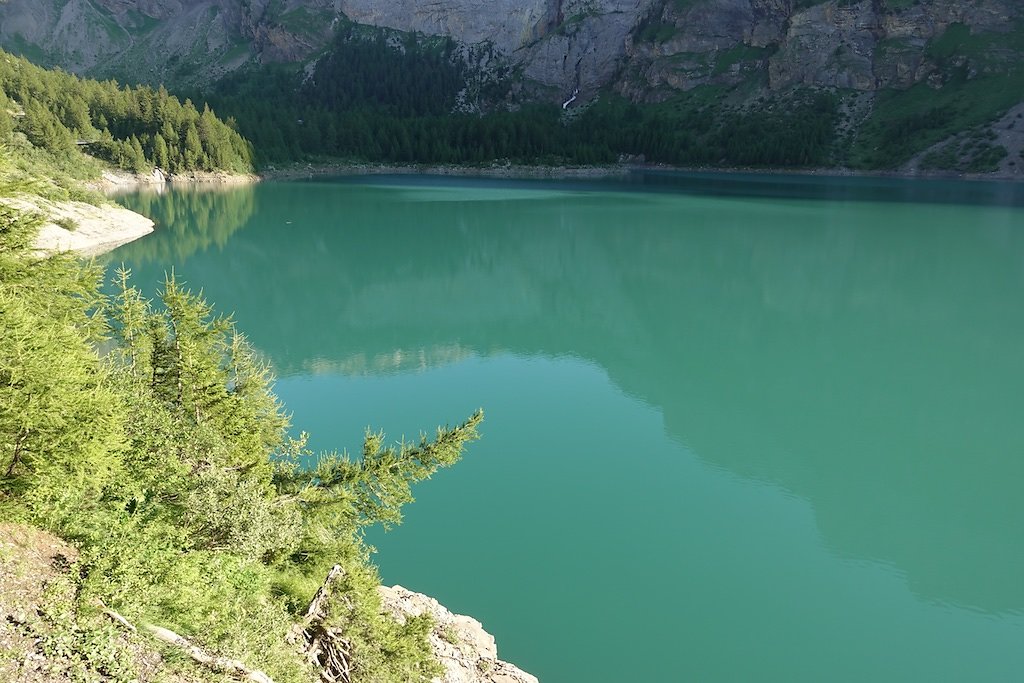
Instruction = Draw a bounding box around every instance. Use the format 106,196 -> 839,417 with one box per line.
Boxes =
0,51 -> 252,173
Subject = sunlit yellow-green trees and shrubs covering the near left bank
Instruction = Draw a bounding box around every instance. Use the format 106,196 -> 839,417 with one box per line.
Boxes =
0,157 -> 481,683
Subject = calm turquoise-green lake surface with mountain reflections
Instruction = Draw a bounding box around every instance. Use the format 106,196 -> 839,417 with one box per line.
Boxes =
111,175 -> 1024,683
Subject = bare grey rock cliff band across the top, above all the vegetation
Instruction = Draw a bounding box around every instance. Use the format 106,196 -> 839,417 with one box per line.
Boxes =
0,0 -> 1024,99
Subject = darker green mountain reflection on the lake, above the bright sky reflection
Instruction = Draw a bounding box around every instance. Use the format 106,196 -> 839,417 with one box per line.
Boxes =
113,178 -> 1024,683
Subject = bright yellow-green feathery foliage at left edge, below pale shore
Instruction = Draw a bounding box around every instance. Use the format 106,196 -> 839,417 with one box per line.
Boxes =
0,169 -> 124,523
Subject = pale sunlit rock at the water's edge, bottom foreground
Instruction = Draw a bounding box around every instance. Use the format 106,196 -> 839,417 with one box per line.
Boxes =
378,586 -> 538,683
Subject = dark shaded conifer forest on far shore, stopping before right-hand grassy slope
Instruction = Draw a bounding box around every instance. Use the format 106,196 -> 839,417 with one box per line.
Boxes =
203,25 -> 840,166
